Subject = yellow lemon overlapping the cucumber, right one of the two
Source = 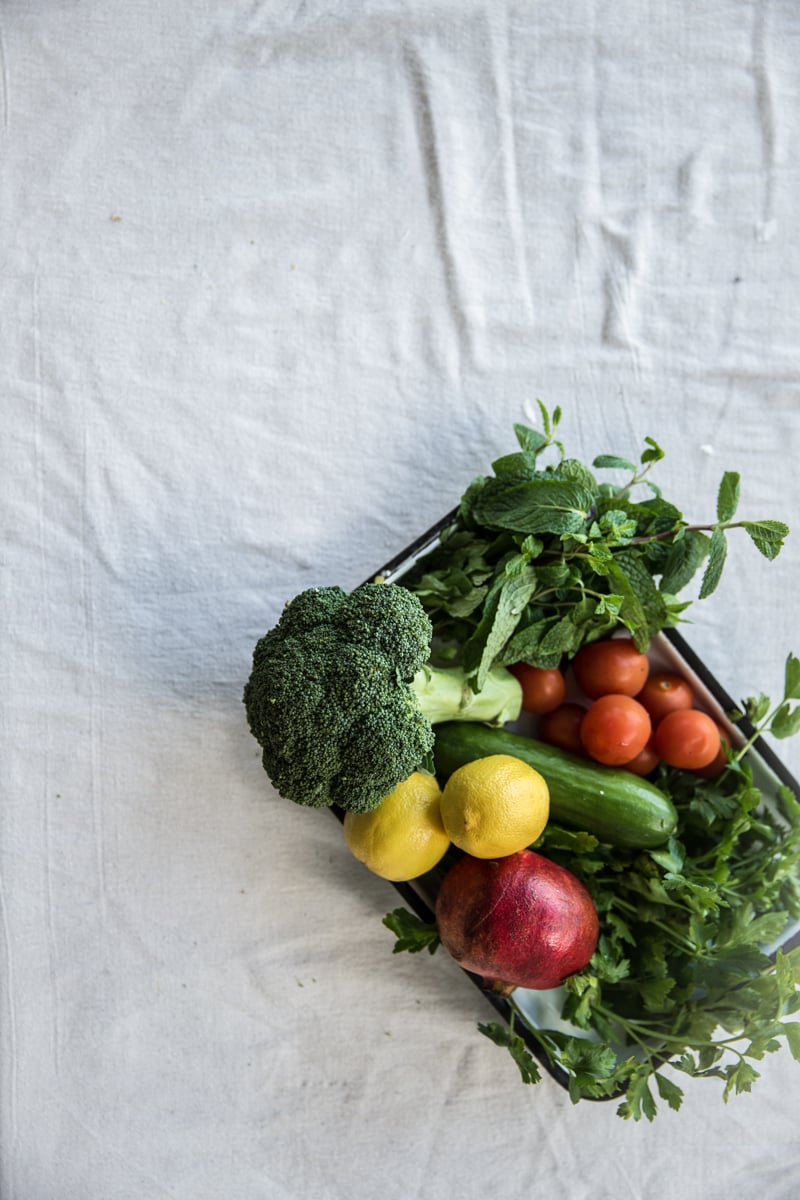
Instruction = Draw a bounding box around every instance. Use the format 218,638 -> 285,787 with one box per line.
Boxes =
441,754 -> 551,858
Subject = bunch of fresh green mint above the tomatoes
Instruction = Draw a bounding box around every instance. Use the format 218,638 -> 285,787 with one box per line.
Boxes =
404,401 -> 789,690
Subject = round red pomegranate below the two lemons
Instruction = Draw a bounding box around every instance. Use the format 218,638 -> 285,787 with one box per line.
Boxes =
437,850 -> 600,995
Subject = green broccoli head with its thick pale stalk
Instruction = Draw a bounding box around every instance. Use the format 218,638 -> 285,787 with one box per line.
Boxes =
243,583 -> 522,812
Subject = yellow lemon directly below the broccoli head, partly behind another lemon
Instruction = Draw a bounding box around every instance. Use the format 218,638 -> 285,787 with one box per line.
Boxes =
344,770 -> 450,883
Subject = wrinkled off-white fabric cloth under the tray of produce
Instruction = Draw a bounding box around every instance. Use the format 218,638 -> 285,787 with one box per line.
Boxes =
0,0 -> 800,1200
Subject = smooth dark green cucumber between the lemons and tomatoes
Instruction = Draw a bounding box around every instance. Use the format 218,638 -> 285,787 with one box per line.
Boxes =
433,721 -> 678,850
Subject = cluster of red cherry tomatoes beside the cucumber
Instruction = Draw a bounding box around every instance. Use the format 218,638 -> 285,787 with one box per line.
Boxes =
511,637 -> 728,776
